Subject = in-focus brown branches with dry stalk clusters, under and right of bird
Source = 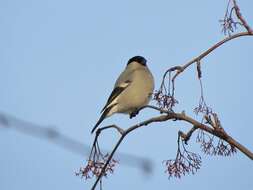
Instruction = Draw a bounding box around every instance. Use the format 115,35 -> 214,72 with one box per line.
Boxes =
87,0 -> 253,190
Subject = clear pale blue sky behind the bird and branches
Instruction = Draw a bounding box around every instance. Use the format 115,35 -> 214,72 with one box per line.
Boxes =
0,0 -> 253,190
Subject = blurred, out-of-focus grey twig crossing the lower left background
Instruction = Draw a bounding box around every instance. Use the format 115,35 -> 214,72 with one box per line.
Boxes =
0,112 -> 153,174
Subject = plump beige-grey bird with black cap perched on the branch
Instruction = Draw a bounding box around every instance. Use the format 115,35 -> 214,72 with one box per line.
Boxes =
91,56 -> 154,133
